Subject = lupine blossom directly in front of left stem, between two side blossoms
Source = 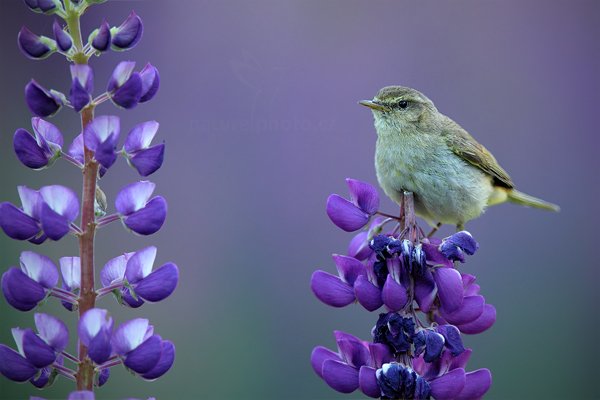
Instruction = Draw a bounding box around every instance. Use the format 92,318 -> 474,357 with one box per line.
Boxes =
83,115 -> 121,168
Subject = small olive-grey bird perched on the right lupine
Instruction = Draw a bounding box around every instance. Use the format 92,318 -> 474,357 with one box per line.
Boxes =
359,86 -> 559,230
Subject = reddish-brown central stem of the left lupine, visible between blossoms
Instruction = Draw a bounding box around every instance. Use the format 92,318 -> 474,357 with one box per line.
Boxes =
66,8 -> 98,390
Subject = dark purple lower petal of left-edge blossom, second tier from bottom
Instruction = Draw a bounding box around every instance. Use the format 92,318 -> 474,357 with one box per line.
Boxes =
2,267 -> 46,311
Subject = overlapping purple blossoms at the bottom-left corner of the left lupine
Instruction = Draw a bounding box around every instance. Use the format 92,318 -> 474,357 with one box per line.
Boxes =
0,314 -> 69,387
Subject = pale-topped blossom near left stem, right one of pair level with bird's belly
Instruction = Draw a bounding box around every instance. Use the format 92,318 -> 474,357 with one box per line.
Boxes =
40,185 -> 79,240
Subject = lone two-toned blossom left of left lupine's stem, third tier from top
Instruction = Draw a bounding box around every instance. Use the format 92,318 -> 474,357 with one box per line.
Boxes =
13,117 -> 63,169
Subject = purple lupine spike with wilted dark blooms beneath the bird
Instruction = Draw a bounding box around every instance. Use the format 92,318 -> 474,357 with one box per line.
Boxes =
311,179 -> 496,400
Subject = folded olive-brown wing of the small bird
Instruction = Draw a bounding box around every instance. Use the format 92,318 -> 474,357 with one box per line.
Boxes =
442,118 -> 515,189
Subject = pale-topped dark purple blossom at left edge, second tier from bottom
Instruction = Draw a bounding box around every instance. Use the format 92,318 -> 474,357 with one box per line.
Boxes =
2,251 -> 58,311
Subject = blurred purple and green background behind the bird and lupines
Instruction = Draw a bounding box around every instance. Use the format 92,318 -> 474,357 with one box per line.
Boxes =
0,0 -> 600,399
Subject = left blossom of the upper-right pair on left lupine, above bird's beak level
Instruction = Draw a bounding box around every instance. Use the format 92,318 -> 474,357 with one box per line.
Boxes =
106,61 -> 142,109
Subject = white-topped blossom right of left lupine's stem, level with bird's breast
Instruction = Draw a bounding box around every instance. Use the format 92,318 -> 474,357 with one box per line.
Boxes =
123,121 -> 165,176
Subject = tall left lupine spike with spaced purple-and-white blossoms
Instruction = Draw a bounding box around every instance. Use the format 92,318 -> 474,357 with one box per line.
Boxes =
0,0 -> 179,400
